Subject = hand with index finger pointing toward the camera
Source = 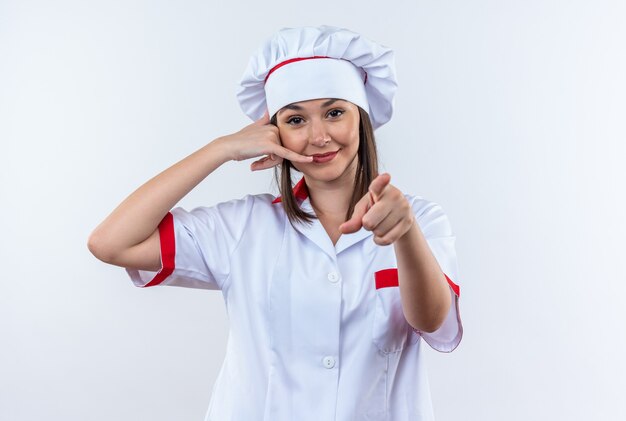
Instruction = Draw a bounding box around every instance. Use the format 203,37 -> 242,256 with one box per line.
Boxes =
339,173 -> 415,246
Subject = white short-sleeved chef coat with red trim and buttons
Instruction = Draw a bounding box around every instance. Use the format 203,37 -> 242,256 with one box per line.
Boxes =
127,181 -> 463,421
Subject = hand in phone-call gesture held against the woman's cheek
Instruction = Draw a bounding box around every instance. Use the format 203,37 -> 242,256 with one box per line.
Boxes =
219,111 -> 313,171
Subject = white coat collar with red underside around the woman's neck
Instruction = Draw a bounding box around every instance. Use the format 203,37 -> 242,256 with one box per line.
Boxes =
272,177 -> 372,259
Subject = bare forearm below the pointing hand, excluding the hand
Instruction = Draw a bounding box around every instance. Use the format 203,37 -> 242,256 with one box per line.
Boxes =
394,222 -> 451,332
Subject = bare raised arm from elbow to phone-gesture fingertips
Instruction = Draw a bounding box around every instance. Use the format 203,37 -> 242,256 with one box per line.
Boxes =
87,108 -> 313,270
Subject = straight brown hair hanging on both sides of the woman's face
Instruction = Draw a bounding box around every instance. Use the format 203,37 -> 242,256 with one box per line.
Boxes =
271,107 -> 378,224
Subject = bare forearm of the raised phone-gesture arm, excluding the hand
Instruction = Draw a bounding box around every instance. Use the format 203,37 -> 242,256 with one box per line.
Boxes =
89,139 -> 230,256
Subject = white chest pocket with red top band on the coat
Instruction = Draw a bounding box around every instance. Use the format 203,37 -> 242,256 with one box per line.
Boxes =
372,268 -> 412,353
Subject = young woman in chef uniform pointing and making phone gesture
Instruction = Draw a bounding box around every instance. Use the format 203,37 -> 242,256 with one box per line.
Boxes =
89,26 -> 462,421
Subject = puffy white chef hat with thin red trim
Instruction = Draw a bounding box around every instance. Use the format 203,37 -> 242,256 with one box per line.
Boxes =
237,26 -> 397,129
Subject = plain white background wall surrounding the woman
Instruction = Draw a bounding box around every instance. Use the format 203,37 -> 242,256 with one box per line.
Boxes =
0,0 -> 626,421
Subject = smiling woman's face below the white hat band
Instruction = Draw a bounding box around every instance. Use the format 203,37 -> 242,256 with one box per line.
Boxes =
276,98 -> 360,182
